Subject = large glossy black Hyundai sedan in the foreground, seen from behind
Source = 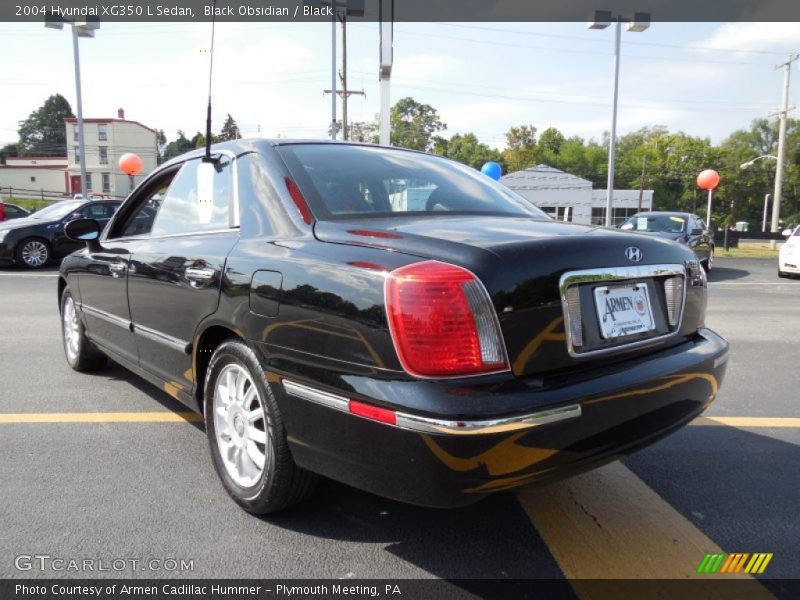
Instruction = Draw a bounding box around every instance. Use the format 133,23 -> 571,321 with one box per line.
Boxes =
58,140 -> 728,513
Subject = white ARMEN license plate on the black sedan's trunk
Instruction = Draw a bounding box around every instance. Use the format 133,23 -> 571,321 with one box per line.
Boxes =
594,283 -> 656,339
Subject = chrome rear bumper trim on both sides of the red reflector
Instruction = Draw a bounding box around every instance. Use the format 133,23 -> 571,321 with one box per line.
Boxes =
283,379 -> 581,435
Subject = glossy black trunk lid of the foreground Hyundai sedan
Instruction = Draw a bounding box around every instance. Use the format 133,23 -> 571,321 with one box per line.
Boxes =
315,215 -> 697,376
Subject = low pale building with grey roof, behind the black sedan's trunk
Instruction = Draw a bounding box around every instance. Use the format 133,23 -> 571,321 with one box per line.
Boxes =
500,165 -> 653,225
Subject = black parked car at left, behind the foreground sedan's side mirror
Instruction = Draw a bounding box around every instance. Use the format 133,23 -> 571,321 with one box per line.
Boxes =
0,200 -> 122,269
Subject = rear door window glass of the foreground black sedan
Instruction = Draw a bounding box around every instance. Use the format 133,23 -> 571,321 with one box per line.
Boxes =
150,156 -> 233,236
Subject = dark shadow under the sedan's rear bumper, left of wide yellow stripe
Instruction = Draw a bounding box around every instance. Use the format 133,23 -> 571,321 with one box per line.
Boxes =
256,479 -> 563,580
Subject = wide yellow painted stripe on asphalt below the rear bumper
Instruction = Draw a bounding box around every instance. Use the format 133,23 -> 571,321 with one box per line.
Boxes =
518,462 -> 771,598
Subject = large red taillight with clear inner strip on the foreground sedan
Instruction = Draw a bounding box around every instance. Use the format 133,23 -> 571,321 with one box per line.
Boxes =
386,261 -> 508,377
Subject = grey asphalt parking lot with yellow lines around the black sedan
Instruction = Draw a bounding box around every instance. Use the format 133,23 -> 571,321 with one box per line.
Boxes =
0,259 -> 800,596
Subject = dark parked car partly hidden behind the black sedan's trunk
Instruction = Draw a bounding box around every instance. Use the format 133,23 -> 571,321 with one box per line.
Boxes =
620,211 -> 714,271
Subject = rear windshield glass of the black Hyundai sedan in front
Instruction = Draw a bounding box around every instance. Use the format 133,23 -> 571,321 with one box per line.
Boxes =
278,144 -> 549,219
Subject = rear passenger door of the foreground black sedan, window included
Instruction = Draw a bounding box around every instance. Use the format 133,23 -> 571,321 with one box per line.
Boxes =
128,155 -> 239,392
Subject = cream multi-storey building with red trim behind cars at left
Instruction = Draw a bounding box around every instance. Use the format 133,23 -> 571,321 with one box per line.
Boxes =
0,108 -> 158,198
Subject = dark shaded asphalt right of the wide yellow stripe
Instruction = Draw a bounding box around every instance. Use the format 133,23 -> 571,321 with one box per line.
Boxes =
624,426 -> 800,598
